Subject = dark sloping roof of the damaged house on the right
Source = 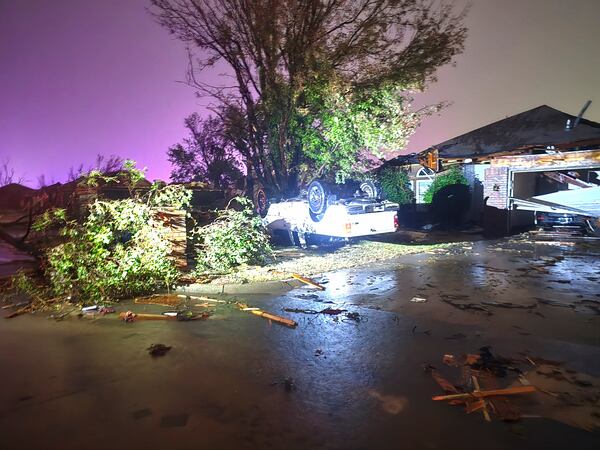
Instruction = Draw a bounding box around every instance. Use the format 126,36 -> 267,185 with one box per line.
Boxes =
428,105 -> 600,158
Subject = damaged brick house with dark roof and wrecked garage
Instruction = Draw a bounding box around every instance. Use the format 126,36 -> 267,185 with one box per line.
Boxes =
386,102 -> 600,234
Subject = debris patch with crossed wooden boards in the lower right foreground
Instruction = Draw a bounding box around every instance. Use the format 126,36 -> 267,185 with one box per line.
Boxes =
424,346 -> 600,431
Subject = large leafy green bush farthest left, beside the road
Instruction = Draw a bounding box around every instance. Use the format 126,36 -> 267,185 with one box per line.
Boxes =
29,167 -> 191,304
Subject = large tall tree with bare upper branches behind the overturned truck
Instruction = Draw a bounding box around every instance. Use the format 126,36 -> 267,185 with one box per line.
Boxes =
152,0 -> 466,192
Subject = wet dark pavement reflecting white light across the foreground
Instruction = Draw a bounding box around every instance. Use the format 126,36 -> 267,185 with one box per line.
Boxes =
0,240 -> 600,450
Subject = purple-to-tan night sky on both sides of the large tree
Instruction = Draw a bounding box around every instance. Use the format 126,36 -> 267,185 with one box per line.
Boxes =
0,0 -> 600,185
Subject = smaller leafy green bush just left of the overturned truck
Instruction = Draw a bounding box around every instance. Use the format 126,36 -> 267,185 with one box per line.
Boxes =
194,197 -> 273,273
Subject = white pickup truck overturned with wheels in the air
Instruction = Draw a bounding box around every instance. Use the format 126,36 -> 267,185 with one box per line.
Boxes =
263,181 -> 399,246
